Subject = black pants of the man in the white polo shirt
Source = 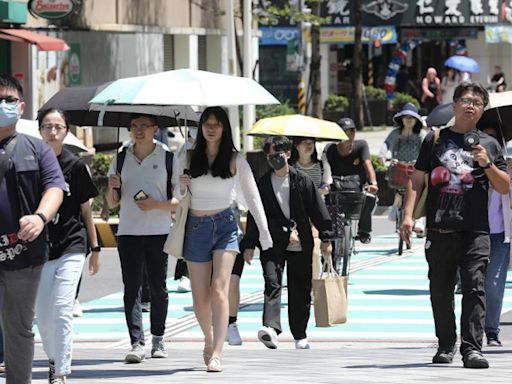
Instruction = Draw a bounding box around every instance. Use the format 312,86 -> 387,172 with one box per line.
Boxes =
117,235 -> 169,345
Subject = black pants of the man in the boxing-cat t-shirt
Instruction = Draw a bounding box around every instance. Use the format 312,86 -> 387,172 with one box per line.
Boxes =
425,231 -> 490,355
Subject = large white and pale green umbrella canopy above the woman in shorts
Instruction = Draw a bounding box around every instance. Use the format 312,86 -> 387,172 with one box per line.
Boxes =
90,69 -> 279,107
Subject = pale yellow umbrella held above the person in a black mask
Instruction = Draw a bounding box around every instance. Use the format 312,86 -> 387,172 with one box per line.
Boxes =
248,115 -> 348,140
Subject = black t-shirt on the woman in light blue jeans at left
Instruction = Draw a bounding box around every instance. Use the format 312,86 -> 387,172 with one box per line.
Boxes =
48,148 -> 98,260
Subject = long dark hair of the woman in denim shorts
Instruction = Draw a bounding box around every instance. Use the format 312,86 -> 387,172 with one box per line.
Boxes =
190,107 -> 238,179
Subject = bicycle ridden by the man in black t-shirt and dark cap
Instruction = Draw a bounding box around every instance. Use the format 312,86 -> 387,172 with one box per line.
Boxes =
326,176 -> 366,276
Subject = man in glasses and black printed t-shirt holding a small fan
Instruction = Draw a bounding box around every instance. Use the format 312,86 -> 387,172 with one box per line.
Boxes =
401,82 -> 510,368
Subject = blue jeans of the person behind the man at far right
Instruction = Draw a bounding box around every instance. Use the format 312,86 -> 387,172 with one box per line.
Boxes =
485,233 -> 510,334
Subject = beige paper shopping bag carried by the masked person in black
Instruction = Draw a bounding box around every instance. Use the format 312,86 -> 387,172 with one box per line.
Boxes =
312,257 -> 348,327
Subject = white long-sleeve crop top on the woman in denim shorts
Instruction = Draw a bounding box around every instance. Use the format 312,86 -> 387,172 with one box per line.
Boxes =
173,153 -> 273,250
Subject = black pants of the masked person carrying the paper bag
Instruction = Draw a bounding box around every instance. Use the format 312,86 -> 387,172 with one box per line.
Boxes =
261,249 -> 312,340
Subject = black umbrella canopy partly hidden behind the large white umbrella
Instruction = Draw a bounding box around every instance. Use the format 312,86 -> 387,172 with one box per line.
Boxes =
39,82 -> 199,127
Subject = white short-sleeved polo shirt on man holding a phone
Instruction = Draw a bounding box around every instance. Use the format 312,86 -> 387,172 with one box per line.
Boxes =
108,143 -> 179,236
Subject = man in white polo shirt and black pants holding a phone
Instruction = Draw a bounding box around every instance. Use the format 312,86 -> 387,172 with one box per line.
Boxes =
106,114 -> 178,363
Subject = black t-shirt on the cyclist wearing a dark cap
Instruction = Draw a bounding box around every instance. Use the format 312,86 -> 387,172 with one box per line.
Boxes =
326,140 -> 370,185
